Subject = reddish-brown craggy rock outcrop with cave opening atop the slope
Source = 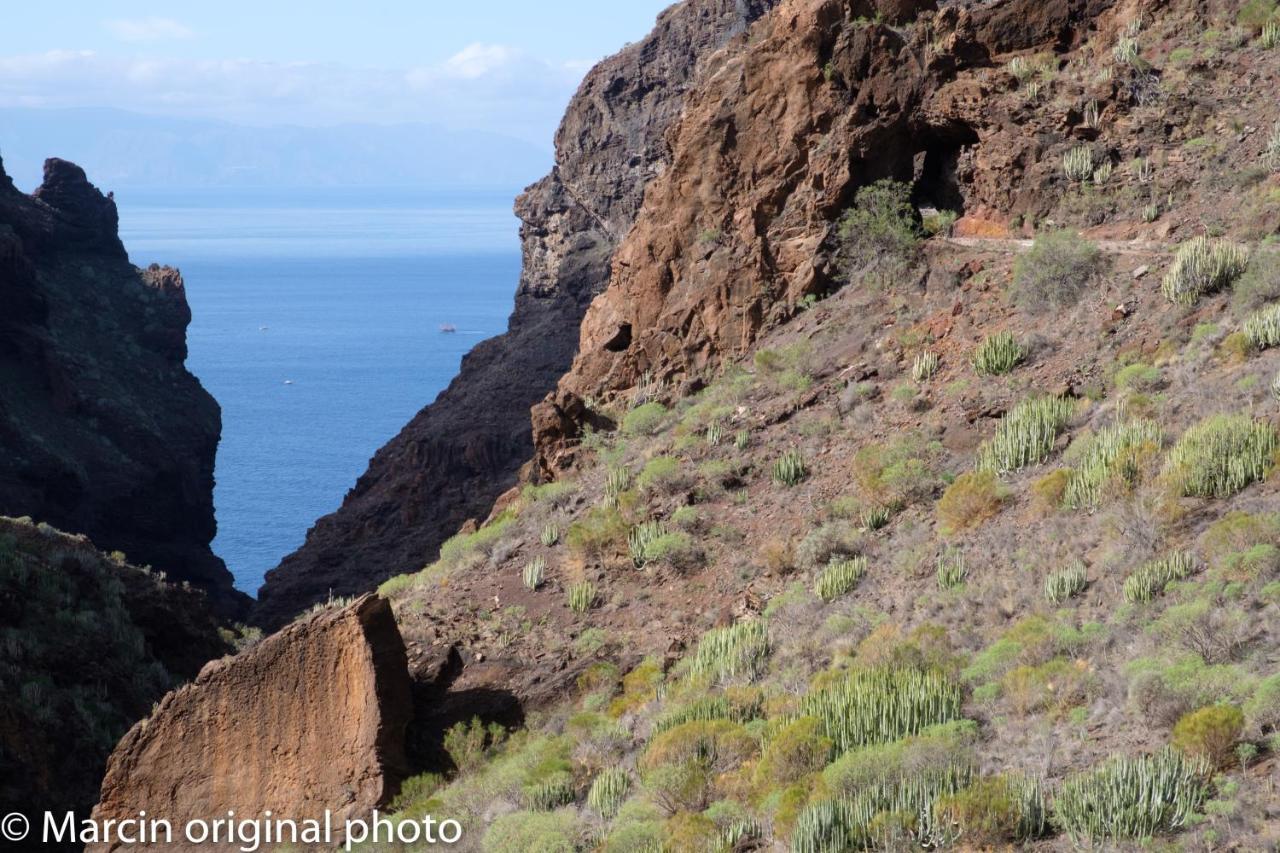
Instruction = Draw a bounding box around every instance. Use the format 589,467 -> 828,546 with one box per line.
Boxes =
534,0 -> 1110,475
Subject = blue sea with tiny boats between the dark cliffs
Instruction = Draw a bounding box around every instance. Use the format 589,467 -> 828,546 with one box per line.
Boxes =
116,190 -> 520,594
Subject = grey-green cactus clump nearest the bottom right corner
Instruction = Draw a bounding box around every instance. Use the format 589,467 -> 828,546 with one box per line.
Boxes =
1053,748 -> 1208,847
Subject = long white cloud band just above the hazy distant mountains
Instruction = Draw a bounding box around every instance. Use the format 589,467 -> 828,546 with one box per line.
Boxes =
0,44 -> 581,146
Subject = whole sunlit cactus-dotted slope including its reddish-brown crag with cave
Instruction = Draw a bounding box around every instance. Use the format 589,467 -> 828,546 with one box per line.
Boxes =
355,0 -> 1280,852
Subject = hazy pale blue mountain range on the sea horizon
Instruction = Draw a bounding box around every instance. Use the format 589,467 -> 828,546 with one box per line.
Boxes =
0,108 -> 552,191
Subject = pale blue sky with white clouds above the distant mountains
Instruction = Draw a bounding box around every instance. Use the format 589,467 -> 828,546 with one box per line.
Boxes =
0,0 -> 669,146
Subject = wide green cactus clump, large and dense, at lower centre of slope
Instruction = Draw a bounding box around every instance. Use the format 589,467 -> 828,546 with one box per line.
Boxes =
800,669 -> 960,753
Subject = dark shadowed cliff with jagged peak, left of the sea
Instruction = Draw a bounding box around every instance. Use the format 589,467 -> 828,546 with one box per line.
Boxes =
0,159 -> 246,615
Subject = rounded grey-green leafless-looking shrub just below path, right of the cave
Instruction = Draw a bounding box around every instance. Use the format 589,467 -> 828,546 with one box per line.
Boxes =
1012,227 -> 1102,314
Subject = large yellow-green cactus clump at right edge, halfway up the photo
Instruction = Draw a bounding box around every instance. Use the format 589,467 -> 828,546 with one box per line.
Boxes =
1162,415 -> 1280,498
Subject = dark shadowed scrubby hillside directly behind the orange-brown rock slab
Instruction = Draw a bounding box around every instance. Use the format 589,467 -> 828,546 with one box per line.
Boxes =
0,517 -> 228,822
